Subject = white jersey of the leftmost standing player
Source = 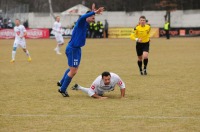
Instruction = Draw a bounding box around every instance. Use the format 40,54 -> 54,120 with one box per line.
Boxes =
14,25 -> 26,43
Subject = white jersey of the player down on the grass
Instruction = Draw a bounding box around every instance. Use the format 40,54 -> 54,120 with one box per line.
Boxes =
88,73 -> 125,96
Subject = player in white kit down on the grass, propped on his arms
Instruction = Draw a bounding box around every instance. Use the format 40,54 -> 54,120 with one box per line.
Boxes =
72,71 -> 125,99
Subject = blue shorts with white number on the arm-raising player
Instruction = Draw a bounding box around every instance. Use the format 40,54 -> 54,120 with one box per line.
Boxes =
65,46 -> 81,67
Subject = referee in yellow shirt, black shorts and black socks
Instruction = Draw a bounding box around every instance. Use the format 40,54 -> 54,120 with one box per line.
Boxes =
130,16 -> 151,75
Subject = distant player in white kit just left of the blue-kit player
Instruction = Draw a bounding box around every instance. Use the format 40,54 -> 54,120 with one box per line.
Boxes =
52,16 -> 64,55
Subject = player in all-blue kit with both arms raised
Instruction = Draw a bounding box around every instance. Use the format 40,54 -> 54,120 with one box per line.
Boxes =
57,4 -> 104,97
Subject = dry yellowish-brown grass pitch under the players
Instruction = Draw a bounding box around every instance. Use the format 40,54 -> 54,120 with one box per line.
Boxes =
0,38 -> 200,132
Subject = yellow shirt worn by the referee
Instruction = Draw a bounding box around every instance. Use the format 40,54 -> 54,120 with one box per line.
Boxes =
130,24 -> 151,43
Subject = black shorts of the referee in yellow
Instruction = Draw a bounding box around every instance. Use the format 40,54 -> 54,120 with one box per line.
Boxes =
136,42 -> 149,56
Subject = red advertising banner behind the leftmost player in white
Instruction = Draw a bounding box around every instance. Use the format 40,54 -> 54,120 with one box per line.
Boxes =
0,28 -> 49,39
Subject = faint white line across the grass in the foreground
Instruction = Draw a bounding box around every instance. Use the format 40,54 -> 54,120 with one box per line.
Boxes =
0,114 -> 200,120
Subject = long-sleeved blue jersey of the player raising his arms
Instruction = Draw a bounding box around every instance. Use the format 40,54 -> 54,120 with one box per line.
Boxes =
68,12 -> 95,48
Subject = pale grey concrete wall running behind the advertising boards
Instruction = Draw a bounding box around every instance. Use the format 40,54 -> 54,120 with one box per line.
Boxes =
28,10 -> 200,28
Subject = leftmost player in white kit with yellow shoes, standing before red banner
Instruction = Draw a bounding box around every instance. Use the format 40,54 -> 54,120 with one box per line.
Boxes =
10,19 -> 31,63
